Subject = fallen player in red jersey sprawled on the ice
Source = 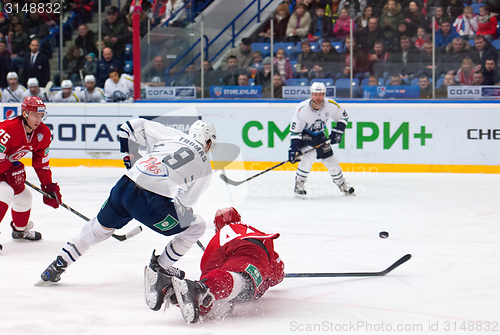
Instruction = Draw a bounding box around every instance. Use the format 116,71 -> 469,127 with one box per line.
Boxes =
146,207 -> 285,323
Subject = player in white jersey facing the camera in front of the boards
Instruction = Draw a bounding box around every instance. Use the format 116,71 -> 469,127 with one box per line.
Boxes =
288,83 -> 354,197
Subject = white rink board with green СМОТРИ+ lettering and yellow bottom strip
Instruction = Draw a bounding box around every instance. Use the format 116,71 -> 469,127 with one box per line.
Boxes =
2,103 -> 500,173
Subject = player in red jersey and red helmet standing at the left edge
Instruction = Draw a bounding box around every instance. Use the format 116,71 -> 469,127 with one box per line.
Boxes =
0,97 -> 61,251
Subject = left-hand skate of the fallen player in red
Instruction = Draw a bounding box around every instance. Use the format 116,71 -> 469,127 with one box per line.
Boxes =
144,250 -> 185,311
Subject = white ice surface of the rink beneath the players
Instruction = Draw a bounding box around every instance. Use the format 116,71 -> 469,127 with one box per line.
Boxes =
0,167 -> 500,335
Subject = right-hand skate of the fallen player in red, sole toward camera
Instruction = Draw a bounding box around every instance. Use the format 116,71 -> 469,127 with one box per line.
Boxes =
172,277 -> 214,323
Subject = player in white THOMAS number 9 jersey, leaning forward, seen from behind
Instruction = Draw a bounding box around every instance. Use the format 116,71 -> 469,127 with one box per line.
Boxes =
41,119 -> 217,288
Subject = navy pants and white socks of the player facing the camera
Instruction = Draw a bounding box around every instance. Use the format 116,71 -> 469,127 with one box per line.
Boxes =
297,133 -> 345,186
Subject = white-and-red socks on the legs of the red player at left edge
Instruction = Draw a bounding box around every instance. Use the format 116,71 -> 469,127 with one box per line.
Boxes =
0,181 -> 33,231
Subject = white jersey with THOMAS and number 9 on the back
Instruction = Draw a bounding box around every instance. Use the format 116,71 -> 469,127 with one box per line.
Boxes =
123,119 -> 212,207
